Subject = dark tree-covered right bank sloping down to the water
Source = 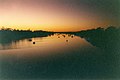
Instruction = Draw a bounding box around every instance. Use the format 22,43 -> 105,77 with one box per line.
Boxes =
76,26 -> 120,51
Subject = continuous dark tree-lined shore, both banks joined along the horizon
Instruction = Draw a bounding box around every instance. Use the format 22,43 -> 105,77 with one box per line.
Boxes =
0,26 -> 120,51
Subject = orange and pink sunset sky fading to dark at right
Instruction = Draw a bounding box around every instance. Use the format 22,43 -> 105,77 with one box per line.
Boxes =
0,0 -> 120,31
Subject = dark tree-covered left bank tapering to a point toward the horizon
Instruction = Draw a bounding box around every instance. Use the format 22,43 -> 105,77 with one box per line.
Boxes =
0,27 -> 53,45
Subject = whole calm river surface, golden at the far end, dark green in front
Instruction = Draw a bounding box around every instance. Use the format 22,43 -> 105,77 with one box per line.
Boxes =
0,34 -> 120,80
